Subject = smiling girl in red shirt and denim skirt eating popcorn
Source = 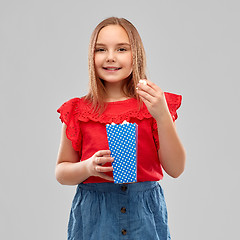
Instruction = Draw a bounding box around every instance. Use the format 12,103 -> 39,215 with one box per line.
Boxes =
56,17 -> 185,240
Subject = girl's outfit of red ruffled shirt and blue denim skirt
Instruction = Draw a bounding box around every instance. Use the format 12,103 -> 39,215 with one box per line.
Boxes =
57,92 -> 182,240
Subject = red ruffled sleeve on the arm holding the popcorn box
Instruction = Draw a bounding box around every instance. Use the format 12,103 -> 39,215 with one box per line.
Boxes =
57,98 -> 82,151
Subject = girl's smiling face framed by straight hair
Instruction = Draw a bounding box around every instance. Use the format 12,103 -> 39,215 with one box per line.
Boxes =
94,25 -> 132,83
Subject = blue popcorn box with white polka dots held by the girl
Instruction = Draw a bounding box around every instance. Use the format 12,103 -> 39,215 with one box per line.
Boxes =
106,121 -> 138,183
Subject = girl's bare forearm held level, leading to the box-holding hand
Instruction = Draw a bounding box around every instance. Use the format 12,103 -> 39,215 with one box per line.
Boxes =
55,160 -> 90,185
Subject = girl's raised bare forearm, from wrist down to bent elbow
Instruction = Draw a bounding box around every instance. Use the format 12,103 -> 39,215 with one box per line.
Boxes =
156,114 -> 186,178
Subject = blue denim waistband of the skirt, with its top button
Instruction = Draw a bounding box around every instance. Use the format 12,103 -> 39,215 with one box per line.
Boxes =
78,181 -> 159,192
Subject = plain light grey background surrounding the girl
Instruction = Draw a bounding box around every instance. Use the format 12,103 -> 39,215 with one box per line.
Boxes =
0,0 -> 240,240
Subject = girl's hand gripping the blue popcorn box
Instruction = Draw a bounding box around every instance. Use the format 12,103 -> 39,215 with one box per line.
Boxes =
87,150 -> 114,181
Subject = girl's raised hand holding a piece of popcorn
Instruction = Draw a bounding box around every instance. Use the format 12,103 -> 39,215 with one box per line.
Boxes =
137,79 -> 170,120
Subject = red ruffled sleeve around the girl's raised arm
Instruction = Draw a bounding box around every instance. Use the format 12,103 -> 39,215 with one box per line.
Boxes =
152,92 -> 182,150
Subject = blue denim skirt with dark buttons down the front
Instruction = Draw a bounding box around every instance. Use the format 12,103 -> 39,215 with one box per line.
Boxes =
68,181 -> 171,240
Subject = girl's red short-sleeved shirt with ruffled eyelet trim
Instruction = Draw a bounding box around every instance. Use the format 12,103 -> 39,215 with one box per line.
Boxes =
57,92 -> 182,183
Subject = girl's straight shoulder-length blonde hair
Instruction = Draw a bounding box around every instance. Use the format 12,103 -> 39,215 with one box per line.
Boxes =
84,17 -> 146,115
